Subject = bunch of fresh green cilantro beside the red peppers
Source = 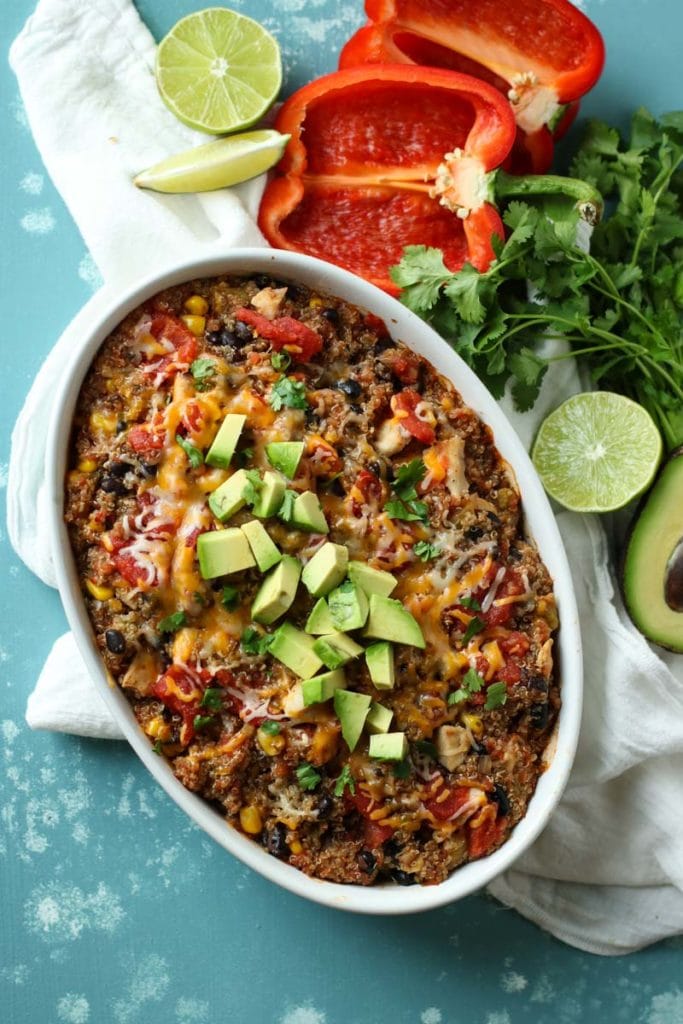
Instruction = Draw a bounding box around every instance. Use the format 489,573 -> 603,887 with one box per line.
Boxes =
392,109 -> 683,447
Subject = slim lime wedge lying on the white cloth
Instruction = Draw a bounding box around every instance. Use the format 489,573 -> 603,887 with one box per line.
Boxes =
133,129 -> 290,193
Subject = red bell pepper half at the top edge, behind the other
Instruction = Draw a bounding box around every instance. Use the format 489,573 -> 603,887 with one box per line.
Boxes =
339,0 -> 604,173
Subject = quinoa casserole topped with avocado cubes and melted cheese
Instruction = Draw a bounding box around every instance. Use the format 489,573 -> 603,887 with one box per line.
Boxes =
66,274 -> 560,885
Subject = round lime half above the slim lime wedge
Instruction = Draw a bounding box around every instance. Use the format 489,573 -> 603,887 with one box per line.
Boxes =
157,7 -> 283,135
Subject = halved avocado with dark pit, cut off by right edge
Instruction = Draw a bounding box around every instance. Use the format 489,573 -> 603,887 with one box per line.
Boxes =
622,446 -> 683,653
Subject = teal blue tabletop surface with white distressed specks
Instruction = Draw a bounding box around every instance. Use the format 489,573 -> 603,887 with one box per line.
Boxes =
0,0 -> 683,1024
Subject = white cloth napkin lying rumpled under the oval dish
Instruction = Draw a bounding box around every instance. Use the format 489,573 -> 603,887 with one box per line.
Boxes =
7,0 -> 683,954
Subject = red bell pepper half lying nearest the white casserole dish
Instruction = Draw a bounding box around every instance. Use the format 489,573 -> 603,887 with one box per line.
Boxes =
259,65 -> 515,294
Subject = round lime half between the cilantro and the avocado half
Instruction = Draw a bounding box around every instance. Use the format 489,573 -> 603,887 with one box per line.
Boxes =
531,391 -> 661,512
